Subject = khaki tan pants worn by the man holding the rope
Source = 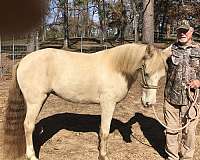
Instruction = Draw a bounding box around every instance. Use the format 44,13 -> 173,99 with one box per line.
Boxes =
164,101 -> 199,160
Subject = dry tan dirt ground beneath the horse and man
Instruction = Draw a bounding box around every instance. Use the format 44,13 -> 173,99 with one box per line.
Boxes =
0,75 -> 200,160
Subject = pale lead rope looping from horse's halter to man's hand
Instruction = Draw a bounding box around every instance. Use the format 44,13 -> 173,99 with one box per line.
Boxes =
152,87 -> 199,131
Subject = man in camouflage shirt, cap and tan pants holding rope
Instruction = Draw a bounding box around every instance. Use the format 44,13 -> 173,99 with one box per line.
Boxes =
164,20 -> 200,160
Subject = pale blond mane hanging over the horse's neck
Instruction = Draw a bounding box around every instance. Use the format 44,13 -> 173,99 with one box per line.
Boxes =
107,43 -> 147,74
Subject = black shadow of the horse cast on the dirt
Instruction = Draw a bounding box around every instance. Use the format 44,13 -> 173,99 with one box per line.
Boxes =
33,113 -> 166,157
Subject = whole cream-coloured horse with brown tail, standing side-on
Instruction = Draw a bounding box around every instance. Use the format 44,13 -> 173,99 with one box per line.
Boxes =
3,43 -> 169,160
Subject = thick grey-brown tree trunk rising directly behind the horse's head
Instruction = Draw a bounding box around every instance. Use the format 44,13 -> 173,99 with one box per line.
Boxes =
142,0 -> 154,43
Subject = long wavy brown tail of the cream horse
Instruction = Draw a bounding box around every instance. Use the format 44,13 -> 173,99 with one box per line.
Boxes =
3,65 -> 26,160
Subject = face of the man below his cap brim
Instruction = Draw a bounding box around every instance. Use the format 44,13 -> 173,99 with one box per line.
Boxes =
177,27 -> 193,45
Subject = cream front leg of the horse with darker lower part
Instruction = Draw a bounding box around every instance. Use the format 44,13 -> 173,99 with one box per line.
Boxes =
99,100 -> 116,160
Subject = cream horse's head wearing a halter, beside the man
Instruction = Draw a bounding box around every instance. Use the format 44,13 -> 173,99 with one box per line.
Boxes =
141,45 -> 166,107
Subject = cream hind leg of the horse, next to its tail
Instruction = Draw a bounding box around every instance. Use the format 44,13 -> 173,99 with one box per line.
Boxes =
24,94 -> 47,160
